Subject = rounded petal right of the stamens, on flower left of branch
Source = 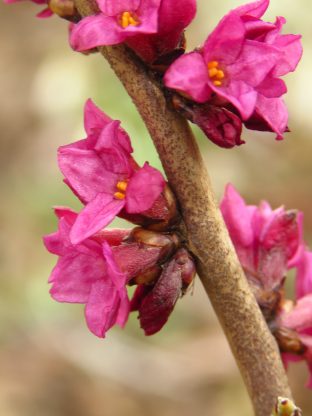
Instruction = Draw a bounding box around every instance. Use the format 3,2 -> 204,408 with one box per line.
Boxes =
126,163 -> 165,214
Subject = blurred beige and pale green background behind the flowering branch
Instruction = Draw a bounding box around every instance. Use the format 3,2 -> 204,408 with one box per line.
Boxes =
0,0 -> 312,416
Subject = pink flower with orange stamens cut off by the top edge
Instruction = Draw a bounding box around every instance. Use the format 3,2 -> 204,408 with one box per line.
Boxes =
70,0 -> 196,62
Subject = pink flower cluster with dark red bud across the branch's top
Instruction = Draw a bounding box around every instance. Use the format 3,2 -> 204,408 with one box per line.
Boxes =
5,0 -> 302,148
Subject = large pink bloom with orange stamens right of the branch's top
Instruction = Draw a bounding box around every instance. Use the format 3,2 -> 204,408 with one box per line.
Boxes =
164,0 -> 302,138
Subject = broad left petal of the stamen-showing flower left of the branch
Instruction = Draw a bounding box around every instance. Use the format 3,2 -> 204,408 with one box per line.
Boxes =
58,146 -> 118,202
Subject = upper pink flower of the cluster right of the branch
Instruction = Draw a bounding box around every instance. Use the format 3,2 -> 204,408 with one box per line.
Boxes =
221,185 -> 302,291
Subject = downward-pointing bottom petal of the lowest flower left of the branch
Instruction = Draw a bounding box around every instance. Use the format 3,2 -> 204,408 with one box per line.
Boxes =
85,279 -> 120,338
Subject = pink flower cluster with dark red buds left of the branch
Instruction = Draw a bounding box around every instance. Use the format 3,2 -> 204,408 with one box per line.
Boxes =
44,100 -> 195,337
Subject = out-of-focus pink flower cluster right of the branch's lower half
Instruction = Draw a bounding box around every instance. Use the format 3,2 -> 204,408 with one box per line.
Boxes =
221,185 -> 312,388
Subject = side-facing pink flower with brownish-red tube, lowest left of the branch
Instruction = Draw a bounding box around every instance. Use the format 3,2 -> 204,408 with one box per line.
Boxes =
44,207 -> 178,337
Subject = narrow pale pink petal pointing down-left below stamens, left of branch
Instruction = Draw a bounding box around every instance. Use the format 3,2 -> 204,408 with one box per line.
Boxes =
70,193 -> 125,244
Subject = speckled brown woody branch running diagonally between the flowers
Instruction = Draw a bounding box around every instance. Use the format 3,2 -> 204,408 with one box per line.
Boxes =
76,0 -> 291,416
